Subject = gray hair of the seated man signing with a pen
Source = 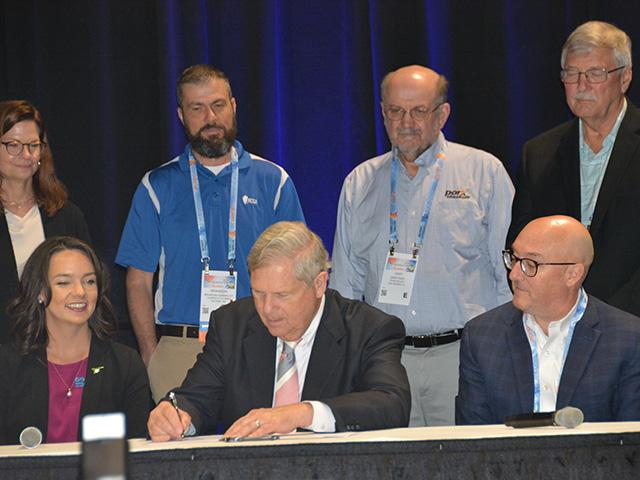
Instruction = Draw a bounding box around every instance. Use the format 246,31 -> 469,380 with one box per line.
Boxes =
247,222 -> 331,286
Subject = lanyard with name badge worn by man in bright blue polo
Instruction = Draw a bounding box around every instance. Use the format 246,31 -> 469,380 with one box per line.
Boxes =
190,145 -> 238,342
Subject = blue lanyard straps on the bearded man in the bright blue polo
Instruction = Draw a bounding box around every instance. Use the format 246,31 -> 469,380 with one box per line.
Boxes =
189,145 -> 238,275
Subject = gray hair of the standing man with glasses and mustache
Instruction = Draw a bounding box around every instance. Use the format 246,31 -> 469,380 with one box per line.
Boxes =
560,20 -> 632,68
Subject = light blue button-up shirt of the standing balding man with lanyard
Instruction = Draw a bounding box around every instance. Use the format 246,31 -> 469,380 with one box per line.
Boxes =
330,133 -> 514,335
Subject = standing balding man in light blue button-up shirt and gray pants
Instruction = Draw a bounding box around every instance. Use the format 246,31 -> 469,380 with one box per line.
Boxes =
330,65 -> 513,427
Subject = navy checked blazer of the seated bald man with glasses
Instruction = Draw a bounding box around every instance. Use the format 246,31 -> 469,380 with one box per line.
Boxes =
456,296 -> 640,424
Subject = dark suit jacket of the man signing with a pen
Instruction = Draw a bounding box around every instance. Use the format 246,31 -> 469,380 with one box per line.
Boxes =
176,289 -> 411,435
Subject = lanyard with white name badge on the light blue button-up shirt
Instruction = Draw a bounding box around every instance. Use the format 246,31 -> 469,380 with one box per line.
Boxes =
378,147 -> 445,306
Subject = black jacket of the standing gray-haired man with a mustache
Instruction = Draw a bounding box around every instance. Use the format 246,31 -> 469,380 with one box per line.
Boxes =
507,100 -> 640,316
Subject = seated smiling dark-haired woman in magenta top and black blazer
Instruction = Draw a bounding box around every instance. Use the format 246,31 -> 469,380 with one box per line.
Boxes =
0,237 -> 151,444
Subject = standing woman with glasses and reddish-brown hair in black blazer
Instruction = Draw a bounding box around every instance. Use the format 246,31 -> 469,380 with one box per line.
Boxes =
0,100 -> 90,343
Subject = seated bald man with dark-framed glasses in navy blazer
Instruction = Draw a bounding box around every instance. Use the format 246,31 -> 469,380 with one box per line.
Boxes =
456,216 -> 640,424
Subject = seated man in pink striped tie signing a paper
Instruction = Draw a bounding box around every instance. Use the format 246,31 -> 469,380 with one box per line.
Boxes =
148,222 -> 411,441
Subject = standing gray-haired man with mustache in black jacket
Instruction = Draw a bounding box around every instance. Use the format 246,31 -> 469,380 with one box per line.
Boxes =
507,21 -> 640,315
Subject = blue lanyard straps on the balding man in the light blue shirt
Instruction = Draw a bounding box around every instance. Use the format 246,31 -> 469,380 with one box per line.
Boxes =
389,147 -> 445,257
